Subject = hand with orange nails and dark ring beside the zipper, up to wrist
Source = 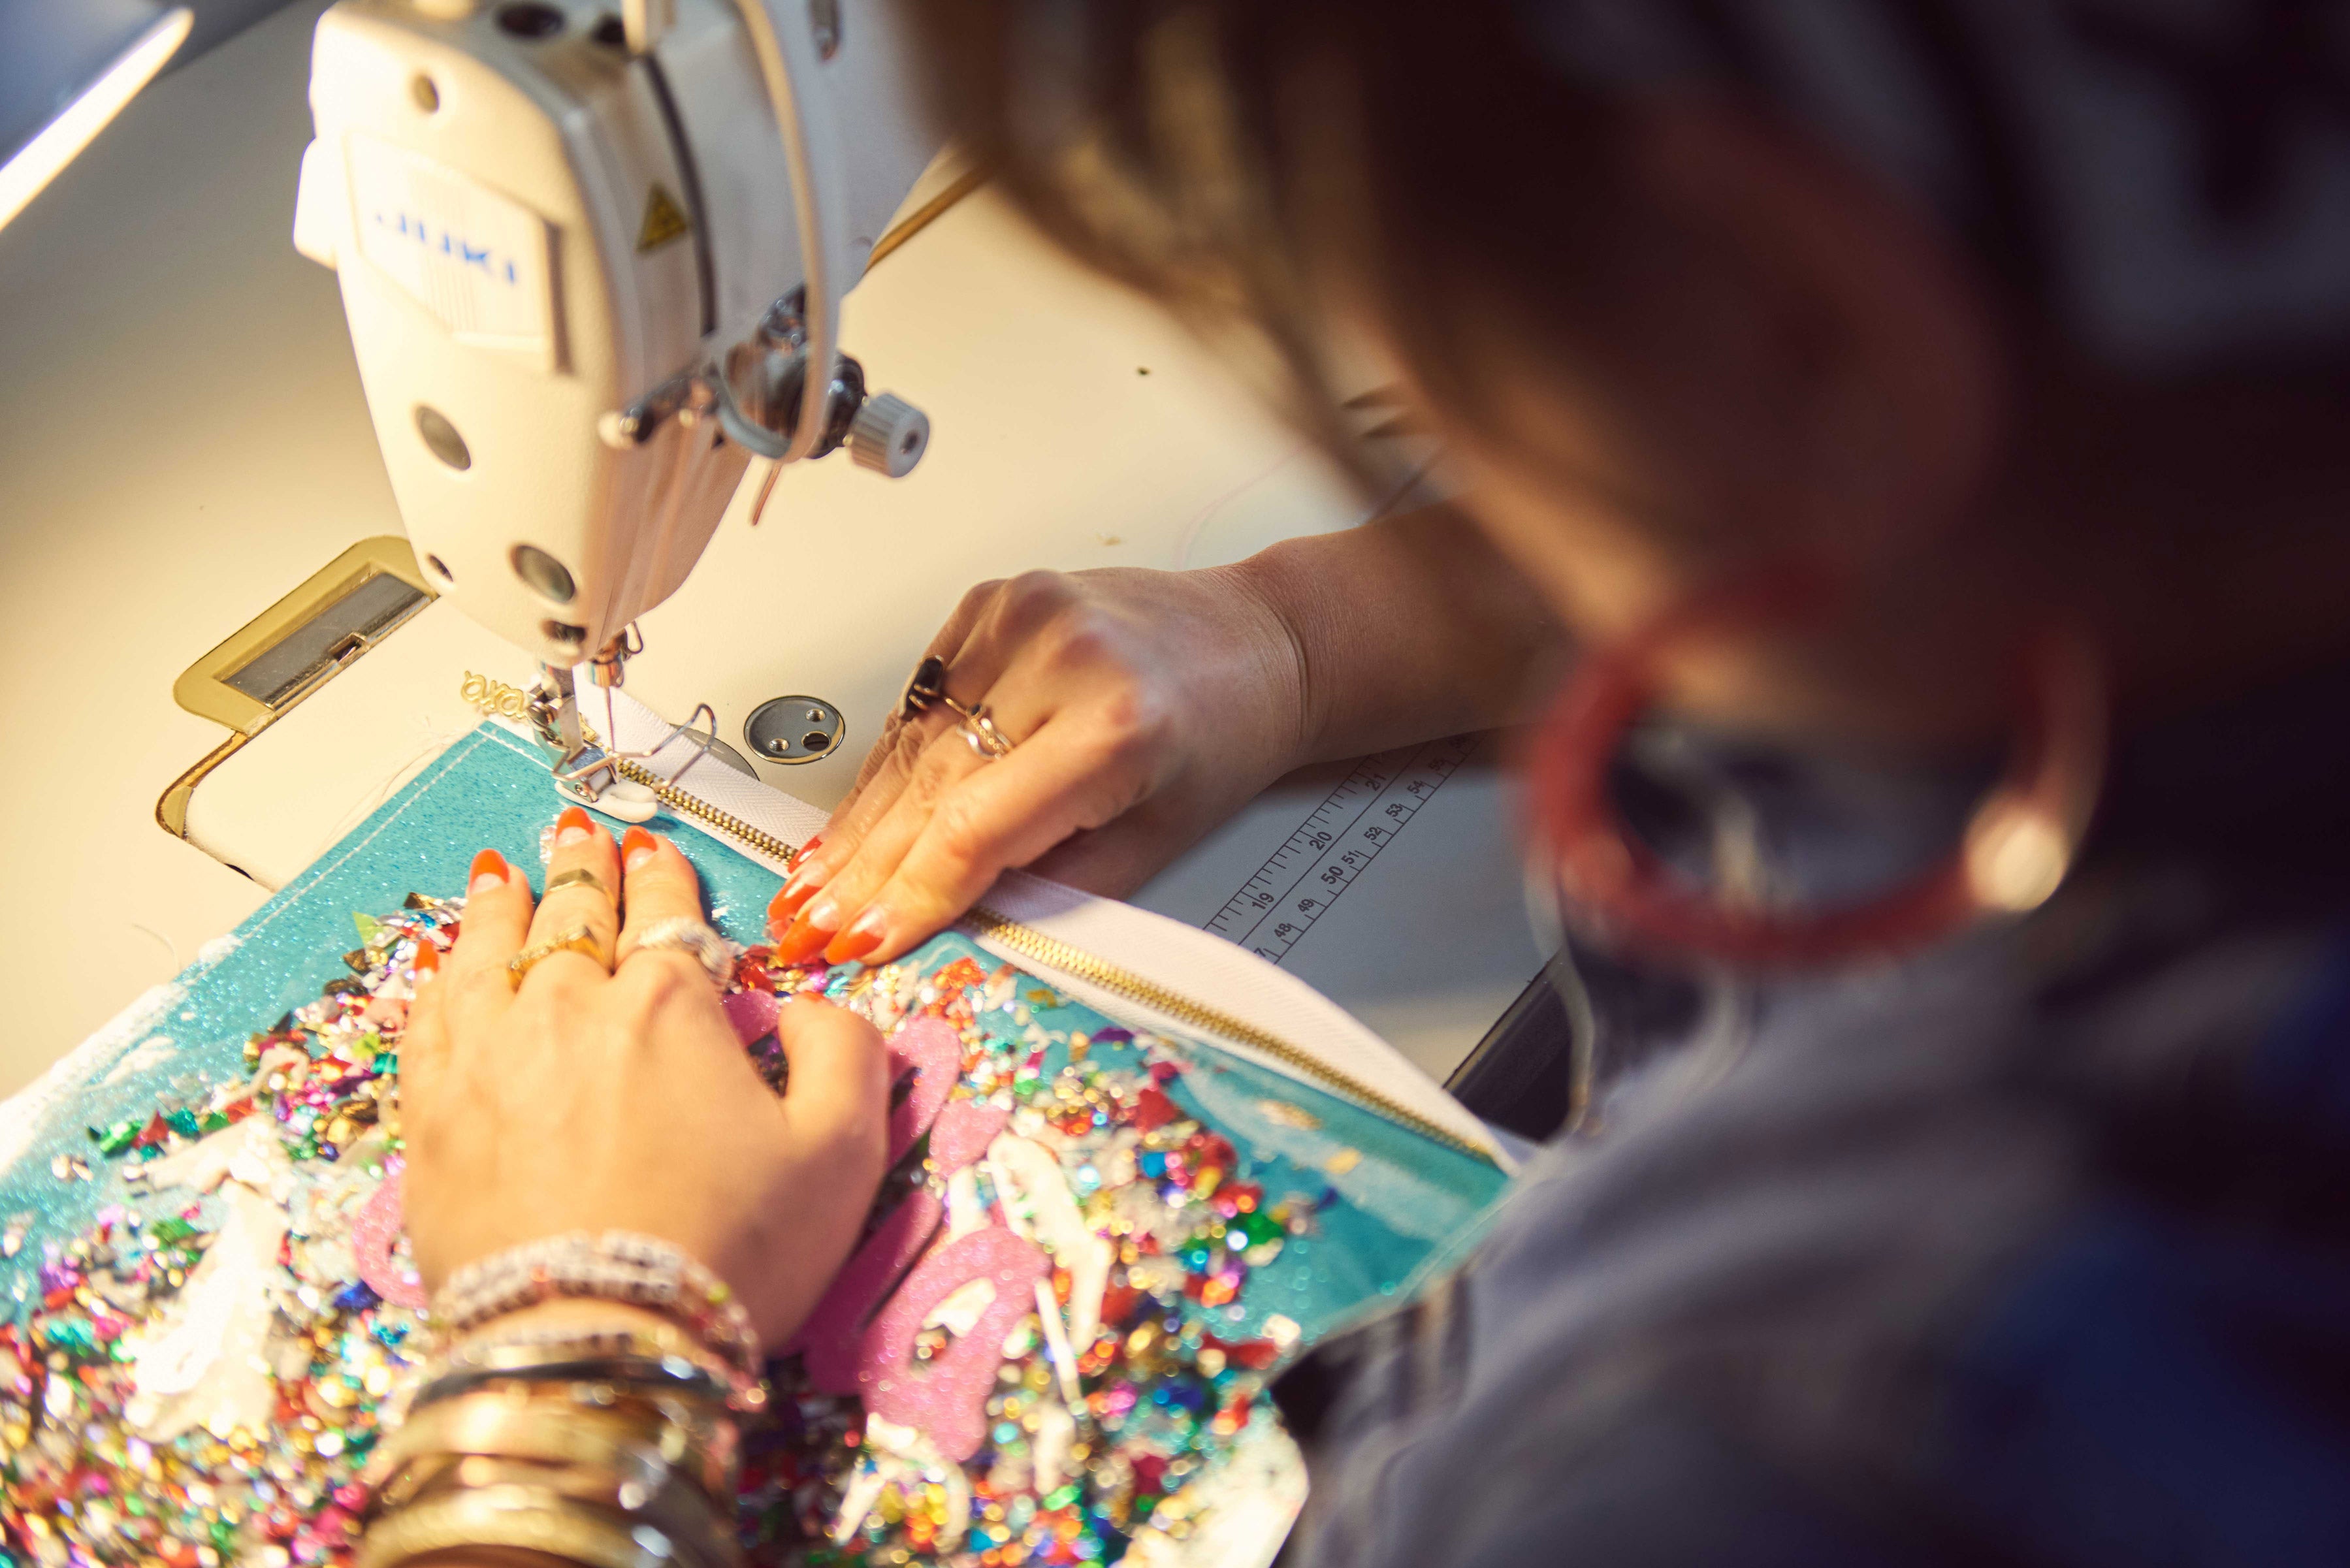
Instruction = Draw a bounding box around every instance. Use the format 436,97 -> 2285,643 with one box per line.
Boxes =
769,569 -> 1304,964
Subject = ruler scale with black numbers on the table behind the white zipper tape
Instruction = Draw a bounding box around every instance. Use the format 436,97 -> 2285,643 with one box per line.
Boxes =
1208,736 -> 1478,964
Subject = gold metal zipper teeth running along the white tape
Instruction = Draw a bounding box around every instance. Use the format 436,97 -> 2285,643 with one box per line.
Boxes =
477,681 -> 1502,1166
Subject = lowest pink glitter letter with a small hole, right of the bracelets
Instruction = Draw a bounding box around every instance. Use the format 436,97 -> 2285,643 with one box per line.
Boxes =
858,1224 -> 1053,1462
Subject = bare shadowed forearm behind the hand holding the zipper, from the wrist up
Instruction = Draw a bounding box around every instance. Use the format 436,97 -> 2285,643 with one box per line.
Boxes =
1225,505 -> 1565,764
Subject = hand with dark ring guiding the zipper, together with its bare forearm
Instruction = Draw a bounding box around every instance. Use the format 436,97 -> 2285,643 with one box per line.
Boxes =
769,508 -> 1560,964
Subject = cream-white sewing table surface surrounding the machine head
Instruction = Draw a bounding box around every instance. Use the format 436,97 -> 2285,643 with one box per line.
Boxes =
0,5 -> 1539,1093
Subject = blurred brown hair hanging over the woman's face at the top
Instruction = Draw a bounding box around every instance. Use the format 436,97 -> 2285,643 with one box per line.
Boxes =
914,0 -> 1640,491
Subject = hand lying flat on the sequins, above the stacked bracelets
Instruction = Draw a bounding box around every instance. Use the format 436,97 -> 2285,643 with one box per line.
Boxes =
400,807 -> 888,1345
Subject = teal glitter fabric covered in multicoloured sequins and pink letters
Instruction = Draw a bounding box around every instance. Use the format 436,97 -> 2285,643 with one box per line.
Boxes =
0,728 -> 1500,1568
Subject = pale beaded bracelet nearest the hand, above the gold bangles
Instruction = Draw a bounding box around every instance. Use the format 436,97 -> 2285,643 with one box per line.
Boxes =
432,1230 -> 764,1380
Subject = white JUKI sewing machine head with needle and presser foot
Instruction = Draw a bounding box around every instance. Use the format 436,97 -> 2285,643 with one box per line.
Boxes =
294,0 -> 938,820
